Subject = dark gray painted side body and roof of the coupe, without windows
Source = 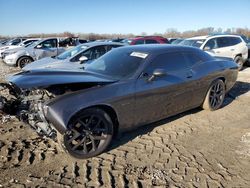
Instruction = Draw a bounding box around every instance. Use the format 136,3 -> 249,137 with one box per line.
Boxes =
32,45 -> 238,133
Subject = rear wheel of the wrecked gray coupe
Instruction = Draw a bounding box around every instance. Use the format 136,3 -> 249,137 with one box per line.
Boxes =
202,80 -> 226,111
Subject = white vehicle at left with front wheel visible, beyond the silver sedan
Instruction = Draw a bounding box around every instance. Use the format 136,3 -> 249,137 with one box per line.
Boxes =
3,38 -> 65,68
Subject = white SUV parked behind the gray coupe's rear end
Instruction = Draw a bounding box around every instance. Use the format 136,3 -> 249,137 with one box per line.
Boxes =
180,35 -> 248,70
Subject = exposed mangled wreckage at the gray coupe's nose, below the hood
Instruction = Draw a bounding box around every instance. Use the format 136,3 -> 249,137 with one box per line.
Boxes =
0,83 -> 56,139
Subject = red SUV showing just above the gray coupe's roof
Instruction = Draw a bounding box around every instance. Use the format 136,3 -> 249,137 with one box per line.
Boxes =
122,36 -> 169,45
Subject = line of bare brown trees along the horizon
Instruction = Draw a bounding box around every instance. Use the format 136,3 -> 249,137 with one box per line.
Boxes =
0,27 -> 250,40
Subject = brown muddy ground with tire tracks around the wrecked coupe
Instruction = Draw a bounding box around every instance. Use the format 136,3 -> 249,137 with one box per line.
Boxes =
0,62 -> 250,187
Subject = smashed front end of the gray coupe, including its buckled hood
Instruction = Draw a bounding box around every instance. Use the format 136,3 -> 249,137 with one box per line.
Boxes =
0,69 -> 115,142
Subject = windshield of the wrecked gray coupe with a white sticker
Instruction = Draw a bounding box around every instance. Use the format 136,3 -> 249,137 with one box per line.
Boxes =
85,48 -> 148,80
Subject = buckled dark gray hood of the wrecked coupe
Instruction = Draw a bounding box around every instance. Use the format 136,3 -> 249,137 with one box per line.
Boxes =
8,68 -> 116,89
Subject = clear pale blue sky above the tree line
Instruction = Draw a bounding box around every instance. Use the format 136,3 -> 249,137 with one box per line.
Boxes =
0,0 -> 250,35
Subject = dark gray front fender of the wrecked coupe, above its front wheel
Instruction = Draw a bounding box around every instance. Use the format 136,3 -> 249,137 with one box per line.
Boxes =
45,82 -> 135,133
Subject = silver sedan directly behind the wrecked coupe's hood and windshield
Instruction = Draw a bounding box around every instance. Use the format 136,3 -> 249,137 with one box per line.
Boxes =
23,42 -> 123,70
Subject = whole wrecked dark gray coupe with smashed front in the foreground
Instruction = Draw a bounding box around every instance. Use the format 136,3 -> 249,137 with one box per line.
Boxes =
0,45 -> 238,159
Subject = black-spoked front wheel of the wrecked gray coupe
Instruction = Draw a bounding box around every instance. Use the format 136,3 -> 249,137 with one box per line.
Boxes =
58,108 -> 114,159
